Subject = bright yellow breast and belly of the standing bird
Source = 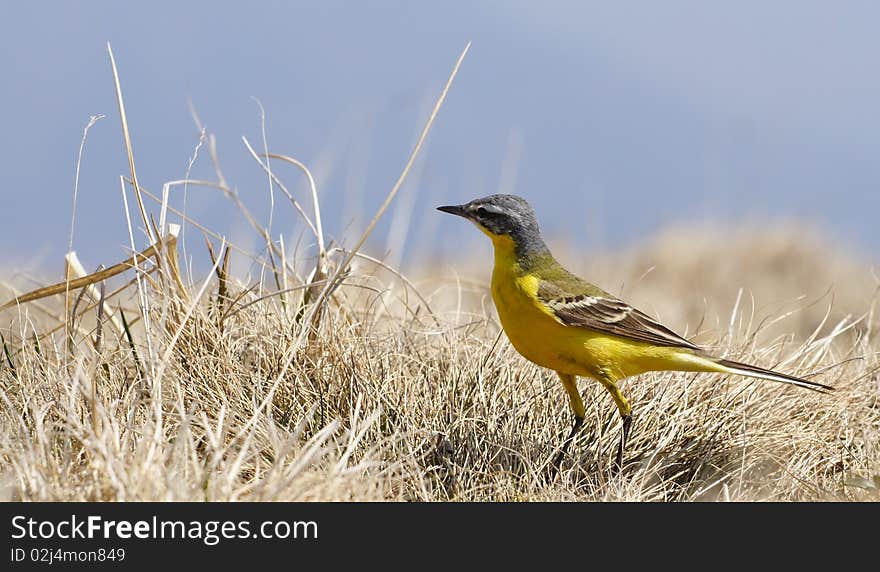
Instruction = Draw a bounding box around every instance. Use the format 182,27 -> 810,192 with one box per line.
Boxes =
492,261 -> 689,380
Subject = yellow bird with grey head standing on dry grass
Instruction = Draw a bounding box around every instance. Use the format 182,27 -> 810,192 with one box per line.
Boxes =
437,194 -> 834,475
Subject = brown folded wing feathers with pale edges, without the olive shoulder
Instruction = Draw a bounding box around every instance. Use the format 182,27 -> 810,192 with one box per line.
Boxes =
544,295 -> 700,350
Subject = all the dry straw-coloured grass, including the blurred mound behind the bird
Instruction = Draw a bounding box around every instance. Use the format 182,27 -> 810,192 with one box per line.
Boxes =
0,44 -> 880,501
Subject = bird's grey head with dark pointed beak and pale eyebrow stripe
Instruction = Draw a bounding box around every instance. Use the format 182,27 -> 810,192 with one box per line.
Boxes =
437,195 -> 543,249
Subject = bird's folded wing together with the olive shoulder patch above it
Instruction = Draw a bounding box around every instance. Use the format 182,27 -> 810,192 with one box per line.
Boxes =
538,275 -> 700,350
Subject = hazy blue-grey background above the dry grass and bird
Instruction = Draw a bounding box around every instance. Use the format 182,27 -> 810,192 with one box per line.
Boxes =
0,1 -> 880,275
